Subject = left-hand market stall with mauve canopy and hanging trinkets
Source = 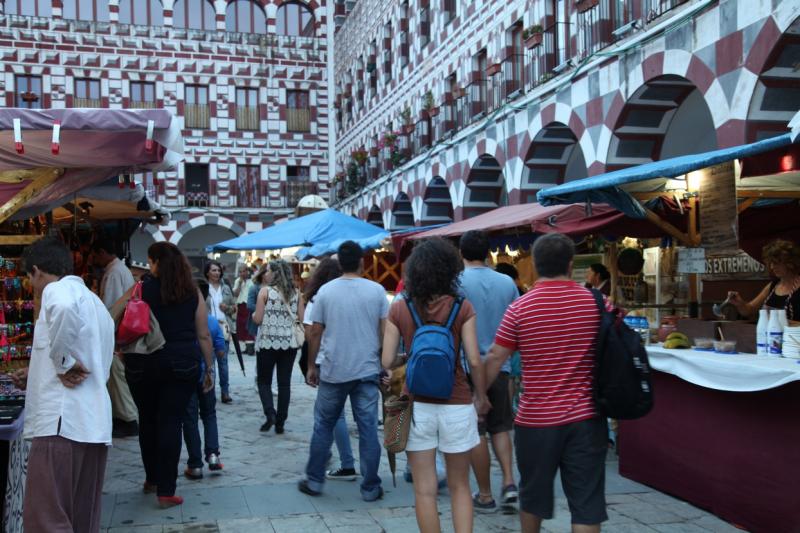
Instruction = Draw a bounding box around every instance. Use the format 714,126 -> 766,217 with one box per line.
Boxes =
0,109 -> 183,532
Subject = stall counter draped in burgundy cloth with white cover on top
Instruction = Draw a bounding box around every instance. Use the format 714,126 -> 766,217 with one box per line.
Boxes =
618,346 -> 800,532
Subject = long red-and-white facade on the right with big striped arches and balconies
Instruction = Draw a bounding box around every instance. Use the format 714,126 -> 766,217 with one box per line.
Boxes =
331,0 -> 800,229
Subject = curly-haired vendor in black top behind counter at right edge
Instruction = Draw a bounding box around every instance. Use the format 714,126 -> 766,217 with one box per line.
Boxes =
728,239 -> 800,325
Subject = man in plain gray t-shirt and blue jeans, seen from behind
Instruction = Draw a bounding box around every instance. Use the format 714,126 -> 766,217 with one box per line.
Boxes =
298,241 -> 389,501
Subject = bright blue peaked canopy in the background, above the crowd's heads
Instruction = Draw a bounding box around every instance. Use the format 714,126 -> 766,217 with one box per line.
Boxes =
206,209 -> 389,252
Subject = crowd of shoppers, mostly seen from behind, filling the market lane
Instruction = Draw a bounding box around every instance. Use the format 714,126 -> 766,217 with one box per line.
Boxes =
15,231 -> 607,532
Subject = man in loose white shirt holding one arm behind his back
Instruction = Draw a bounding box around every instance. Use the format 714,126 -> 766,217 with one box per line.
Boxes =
13,237 -> 114,532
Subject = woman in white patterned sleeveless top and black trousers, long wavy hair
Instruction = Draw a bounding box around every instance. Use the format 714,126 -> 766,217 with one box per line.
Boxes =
253,259 -> 303,435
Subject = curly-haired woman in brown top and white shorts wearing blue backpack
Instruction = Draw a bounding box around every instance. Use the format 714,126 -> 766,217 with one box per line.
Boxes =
381,238 -> 489,533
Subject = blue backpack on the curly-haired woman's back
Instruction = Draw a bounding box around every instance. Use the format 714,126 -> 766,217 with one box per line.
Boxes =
403,294 -> 464,400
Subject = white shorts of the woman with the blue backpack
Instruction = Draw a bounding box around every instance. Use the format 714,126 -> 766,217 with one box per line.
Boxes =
406,402 -> 480,453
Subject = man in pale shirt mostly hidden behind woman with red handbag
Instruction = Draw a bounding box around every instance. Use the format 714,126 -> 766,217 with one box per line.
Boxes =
92,240 -> 139,438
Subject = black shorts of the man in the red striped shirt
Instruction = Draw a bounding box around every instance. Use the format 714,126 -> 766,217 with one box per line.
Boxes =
514,417 -> 608,525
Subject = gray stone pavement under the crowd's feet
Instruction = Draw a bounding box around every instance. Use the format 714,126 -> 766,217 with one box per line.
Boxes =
102,354 -> 739,533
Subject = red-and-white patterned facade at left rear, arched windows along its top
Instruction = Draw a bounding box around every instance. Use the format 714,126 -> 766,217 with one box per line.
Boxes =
0,0 -> 333,262
